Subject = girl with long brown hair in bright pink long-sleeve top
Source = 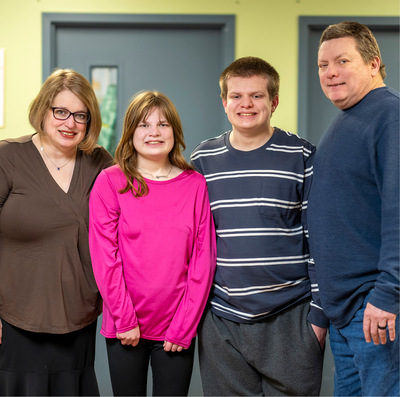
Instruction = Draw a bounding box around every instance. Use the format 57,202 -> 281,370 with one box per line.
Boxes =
89,91 -> 216,396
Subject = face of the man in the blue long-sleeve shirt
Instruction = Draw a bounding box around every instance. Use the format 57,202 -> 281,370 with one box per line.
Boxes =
318,37 -> 383,109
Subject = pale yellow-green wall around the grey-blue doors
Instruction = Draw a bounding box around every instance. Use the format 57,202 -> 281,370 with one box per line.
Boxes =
0,0 -> 400,139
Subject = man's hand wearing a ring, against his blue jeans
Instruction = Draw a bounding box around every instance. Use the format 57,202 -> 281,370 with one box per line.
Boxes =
363,303 -> 396,345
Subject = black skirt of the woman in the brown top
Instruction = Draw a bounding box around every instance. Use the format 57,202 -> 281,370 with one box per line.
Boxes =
0,320 -> 99,396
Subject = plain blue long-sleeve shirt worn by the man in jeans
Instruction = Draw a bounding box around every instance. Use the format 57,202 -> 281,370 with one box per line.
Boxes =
308,87 -> 400,328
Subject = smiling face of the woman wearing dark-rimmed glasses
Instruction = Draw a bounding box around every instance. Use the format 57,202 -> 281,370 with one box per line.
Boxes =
42,90 -> 88,152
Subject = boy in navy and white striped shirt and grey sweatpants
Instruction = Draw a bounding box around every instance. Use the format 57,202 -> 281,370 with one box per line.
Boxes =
192,57 -> 327,396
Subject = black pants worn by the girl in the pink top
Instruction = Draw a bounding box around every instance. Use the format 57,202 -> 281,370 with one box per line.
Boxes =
106,339 -> 195,396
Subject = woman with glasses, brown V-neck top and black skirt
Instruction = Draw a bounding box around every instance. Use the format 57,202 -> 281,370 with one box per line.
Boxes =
0,70 -> 112,396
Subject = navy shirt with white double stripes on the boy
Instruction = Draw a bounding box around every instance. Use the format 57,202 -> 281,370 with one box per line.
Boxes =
191,128 -> 323,325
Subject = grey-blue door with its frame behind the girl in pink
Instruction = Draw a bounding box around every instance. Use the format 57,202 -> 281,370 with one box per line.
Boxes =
43,14 -> 234,396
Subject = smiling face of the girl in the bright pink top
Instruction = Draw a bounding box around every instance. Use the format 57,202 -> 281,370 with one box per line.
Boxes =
133,108 -> 174,164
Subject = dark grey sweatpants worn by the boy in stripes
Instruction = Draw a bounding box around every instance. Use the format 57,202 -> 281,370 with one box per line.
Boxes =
199,300 -> 323,396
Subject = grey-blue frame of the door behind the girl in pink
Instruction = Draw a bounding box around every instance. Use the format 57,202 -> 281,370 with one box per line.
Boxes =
42,13 -> 235,81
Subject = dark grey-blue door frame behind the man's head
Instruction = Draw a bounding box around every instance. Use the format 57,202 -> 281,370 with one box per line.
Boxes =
297,15 -> 399,139
